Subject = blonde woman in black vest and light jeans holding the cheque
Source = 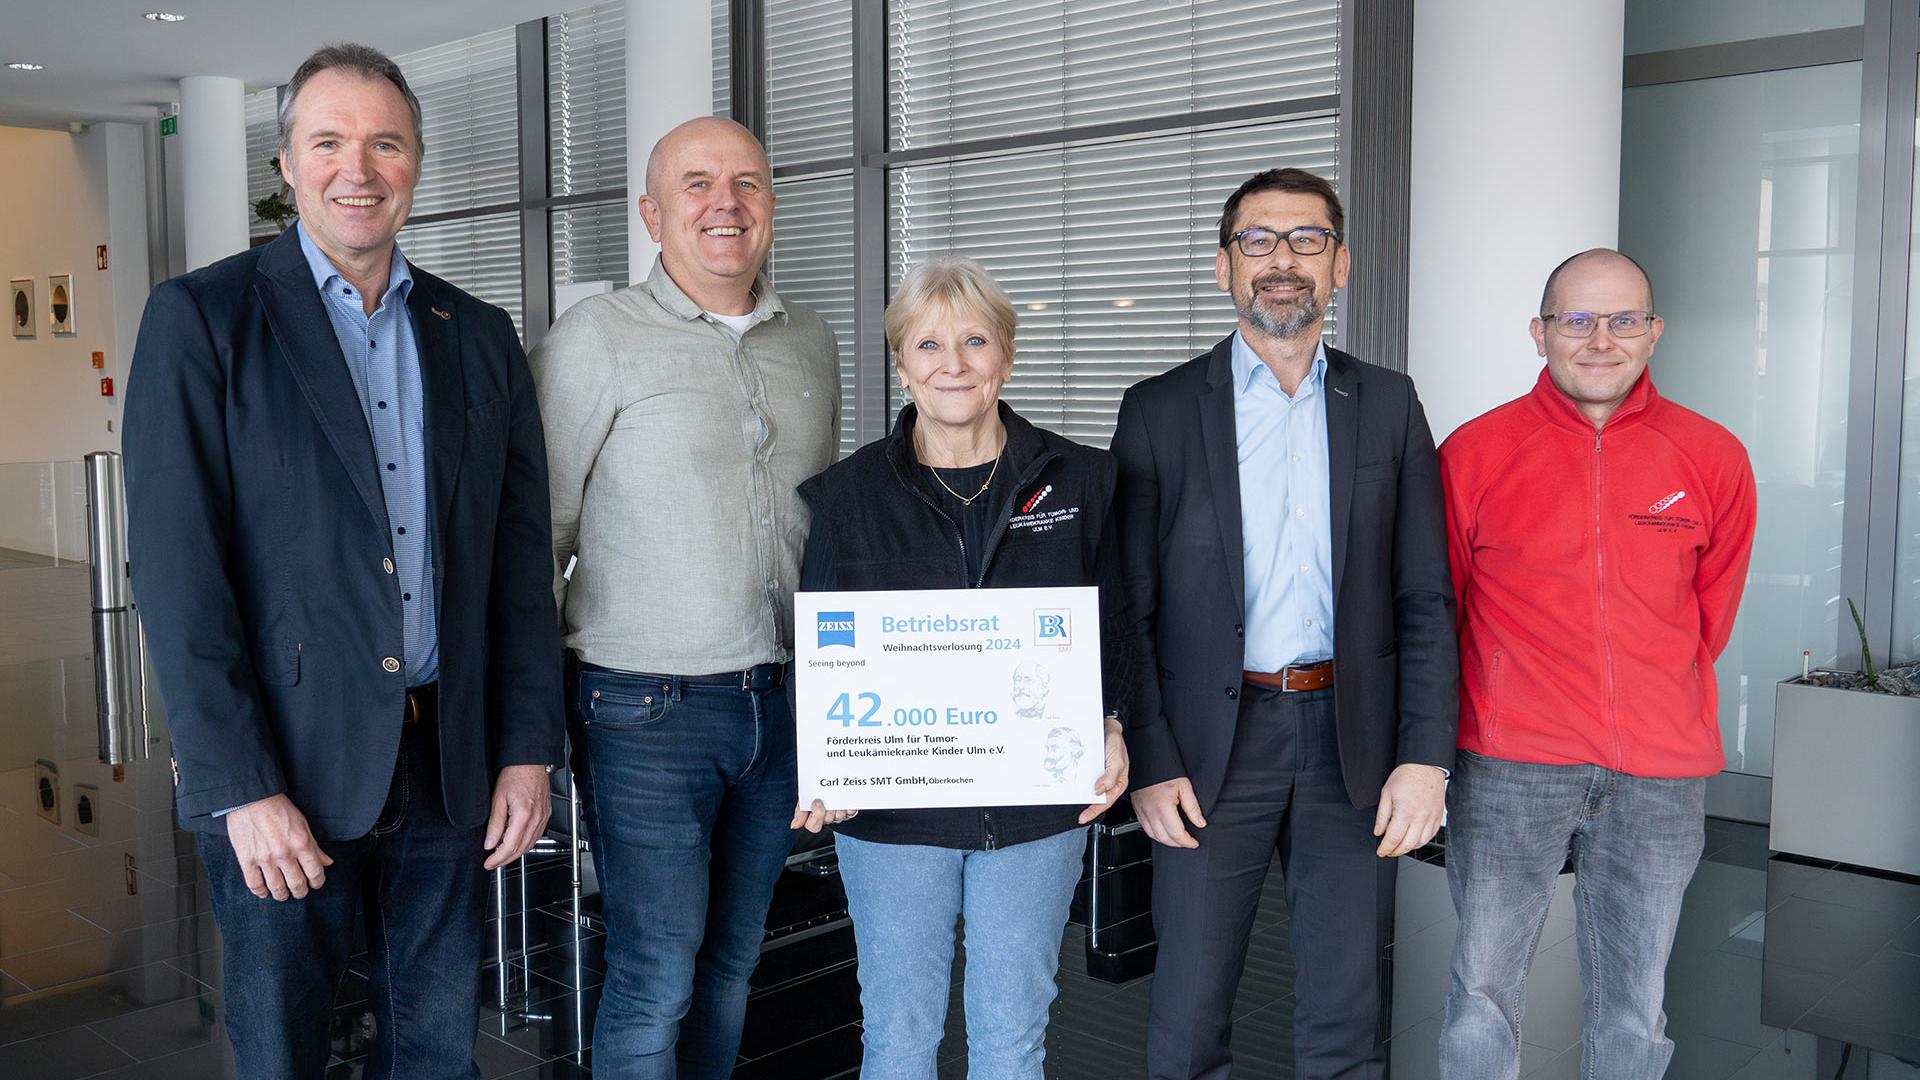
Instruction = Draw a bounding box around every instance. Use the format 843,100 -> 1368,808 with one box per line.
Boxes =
793,258 -> 1129,1080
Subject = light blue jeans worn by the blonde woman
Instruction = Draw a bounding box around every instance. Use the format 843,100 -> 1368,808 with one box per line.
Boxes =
833,828 -> 1087,1080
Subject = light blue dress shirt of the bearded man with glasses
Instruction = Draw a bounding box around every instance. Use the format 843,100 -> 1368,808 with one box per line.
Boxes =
1233,332 -> 1332,671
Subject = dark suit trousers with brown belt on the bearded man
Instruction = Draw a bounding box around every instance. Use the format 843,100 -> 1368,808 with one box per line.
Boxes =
1146,684 -> 1396,1080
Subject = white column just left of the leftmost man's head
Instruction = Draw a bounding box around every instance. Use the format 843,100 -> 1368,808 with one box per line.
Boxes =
173,75 -> 250,267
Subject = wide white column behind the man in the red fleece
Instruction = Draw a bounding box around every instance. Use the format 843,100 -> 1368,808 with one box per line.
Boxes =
1407,0 -> 1624,438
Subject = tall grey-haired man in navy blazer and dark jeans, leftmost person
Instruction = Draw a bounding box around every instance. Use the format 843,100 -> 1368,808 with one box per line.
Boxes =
125,46 -> 564,1080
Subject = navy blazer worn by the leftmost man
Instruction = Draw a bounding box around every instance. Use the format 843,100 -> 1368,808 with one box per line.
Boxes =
125,229 -> 564,837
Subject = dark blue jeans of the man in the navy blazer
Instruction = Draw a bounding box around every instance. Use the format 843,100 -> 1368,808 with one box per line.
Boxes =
200,724 -> 486,1080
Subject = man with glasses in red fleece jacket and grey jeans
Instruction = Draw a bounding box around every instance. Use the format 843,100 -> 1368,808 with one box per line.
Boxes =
1440,248 -> 1753,1080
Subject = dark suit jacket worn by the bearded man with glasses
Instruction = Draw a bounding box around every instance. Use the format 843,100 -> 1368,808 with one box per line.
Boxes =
1114,338 -> 1459,813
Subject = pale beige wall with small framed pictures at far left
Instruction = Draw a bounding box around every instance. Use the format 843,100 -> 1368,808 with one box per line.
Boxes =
0,123 -> 148,557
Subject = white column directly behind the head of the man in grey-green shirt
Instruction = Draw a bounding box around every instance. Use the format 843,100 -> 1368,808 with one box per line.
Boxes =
626,0 -> 714,282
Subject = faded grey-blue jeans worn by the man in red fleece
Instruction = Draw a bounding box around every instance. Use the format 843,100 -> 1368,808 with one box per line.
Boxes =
1440,751 -> 1707,1080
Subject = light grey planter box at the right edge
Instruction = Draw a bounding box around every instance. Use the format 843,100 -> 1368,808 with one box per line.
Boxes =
1770,682 -> 1920,876
